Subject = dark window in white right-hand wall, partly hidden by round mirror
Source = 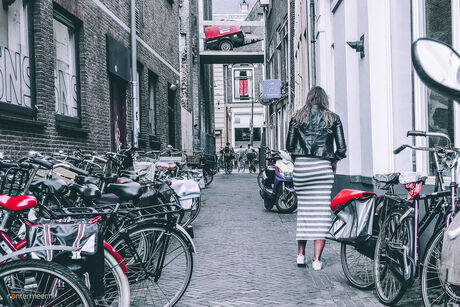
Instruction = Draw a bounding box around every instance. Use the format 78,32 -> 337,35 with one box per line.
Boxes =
425,0 -> 454,175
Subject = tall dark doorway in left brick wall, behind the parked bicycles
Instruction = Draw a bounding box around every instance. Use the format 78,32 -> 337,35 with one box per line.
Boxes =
109,76 -> 128,151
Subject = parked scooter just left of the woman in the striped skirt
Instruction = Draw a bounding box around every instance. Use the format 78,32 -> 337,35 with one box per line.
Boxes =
257,151 -> 297,213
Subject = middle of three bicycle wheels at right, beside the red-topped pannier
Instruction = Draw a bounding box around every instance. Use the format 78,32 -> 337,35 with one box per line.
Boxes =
373,209 -> 414,305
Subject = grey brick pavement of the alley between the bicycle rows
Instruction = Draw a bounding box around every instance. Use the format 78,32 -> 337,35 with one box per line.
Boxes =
178,174 -> 422,306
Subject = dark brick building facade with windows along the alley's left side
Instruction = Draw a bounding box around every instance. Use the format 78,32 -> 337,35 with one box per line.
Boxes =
0,0 -> 215,158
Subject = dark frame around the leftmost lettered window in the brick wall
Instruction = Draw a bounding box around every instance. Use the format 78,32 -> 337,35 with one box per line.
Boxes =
0,0 -> 37,119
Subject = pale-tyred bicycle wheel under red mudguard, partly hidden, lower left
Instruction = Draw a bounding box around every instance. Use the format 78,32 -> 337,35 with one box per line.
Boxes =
96,250 -> 130,307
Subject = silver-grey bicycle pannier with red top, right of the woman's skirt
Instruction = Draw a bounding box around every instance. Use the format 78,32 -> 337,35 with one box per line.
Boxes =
329,190 -> 376,242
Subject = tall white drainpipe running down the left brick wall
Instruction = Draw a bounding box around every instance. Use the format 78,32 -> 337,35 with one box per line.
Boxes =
131,0 -> 139,147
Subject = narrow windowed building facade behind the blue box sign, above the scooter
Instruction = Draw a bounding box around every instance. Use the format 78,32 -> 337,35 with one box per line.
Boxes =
264,0 -> 294,150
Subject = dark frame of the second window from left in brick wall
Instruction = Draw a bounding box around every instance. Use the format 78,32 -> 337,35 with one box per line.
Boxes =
53,4 -> 82,127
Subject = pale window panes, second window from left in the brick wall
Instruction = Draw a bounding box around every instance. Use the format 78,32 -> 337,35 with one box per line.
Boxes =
53,13 -> 80,118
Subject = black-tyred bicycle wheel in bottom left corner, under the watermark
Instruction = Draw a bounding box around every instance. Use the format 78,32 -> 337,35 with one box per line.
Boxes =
0,260 -> 95,307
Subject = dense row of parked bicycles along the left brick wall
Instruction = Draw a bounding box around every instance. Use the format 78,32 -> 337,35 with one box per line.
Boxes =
0,148 -> 212,306
